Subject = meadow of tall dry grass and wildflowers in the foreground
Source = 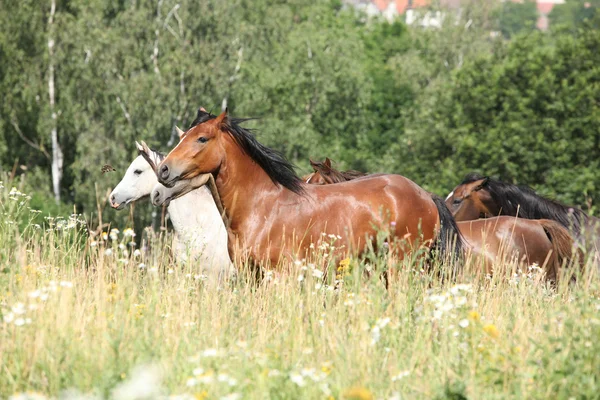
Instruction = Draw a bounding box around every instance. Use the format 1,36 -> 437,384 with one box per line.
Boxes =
0,179 -> 600,400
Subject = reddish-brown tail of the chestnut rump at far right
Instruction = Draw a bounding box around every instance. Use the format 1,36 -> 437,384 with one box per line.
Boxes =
538,219 -> 583,282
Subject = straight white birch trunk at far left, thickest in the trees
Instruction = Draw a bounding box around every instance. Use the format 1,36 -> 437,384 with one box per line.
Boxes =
48,0 -> 63,203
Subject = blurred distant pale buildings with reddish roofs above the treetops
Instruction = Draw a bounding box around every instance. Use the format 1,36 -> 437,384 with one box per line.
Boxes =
346,0 -> 565,30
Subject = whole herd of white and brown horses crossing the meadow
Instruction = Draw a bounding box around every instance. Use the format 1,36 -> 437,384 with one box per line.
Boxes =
109,108 -> 600,281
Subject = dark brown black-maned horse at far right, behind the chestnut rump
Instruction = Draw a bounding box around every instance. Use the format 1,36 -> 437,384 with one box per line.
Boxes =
446,173 -> 600,250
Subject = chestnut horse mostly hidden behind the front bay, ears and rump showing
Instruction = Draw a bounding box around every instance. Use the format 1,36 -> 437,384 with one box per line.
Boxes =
303,158 -> 573,280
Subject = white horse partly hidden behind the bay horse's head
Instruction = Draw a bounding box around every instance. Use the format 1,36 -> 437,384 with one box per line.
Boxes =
109,142 -> 235,278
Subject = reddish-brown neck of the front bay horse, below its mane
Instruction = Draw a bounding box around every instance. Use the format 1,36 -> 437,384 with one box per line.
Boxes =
215,136 -> 292,222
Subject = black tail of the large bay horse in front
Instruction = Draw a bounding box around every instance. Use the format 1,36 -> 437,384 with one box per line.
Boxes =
431,195 -> 464,267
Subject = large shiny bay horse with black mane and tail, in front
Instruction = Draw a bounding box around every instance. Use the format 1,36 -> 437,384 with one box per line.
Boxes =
158,109 -> 461,267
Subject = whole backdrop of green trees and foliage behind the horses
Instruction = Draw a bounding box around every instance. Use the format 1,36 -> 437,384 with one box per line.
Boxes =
0,0 -> 600,222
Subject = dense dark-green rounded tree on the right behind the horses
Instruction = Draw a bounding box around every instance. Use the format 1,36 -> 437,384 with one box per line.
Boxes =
402,24 -> 600,209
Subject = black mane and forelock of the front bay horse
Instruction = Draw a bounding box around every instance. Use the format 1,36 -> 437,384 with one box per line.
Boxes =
190,110 -> 304,194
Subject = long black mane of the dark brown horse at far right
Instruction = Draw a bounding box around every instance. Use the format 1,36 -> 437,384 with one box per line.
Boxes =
462,173 -> 589,234
